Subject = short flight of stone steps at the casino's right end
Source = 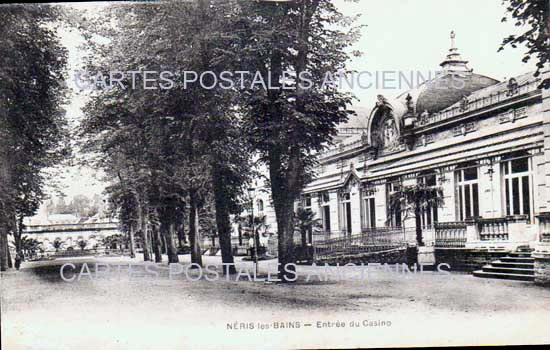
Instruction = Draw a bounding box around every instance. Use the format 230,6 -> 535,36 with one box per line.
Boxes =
473,250 -> 535,281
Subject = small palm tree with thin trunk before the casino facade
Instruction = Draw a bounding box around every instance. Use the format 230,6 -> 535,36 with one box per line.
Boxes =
388,183 -> 444,246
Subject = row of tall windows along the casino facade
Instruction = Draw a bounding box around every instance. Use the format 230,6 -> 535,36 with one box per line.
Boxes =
302,154 -> 533,233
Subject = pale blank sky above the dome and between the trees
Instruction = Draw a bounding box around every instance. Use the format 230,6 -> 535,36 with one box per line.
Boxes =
47,0 -> 535,205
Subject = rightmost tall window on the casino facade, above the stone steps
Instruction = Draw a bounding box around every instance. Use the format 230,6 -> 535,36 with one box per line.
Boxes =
502,153 -> 532,217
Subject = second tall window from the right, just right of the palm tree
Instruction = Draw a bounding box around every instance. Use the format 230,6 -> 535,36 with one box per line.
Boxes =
455,163 -> 479,221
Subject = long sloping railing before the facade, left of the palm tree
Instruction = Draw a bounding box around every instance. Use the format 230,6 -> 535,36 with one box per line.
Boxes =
313,227 -> 407,259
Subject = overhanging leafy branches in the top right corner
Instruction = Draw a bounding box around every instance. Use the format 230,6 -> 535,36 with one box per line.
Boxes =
499,0 -> 550,89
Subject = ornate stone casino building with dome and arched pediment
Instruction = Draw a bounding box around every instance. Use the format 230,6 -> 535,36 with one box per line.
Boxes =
256,33 -> 550,280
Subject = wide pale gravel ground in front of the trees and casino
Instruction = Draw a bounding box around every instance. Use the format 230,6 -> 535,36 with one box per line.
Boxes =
1,256 -> 550,350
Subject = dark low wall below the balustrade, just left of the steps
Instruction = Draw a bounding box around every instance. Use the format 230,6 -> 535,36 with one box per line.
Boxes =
435,248 -> 508,272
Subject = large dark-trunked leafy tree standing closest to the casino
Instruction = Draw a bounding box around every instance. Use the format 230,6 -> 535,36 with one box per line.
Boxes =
230,0 -> 358,282
